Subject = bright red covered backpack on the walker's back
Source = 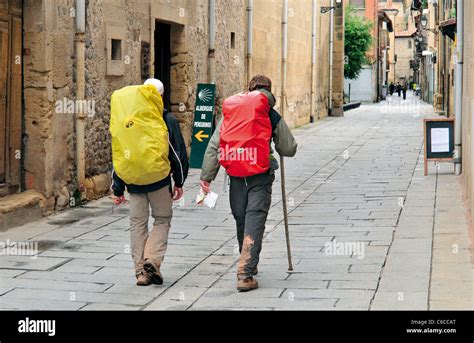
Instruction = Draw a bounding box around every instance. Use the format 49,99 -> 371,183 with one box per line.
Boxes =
219,91 -> 272,177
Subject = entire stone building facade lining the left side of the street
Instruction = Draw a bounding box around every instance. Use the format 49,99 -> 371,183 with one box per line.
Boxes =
0,0 -> 343,232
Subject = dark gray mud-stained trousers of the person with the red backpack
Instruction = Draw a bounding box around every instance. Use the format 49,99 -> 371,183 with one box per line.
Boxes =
230,173 -> 275,280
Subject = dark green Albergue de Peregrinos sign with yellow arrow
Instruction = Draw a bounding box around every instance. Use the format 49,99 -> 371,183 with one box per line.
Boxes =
190,83 -> 216,168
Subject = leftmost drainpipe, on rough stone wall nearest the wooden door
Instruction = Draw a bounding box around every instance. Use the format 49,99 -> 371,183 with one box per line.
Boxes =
75,0 -> 86,192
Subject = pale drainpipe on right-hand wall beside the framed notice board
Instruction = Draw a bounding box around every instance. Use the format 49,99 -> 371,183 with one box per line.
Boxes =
454,0 -> 464,175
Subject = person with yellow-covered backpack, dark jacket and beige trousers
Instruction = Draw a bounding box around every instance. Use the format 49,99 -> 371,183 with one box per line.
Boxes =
110,79 -> 189,286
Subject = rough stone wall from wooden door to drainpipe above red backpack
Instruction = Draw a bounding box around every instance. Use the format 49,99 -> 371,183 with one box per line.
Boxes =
20,0 -> 246,210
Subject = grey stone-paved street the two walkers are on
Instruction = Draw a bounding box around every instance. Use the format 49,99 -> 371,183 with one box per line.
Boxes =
0,94 -> 474,310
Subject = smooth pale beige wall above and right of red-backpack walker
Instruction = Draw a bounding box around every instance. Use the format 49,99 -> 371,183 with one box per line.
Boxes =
253,0 -> 330,127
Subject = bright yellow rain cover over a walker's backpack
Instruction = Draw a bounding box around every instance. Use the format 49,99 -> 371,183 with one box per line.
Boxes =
110,85 -> 171,185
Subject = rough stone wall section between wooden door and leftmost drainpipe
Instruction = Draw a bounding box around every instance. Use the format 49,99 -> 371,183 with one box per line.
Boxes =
23,0 -> 75,211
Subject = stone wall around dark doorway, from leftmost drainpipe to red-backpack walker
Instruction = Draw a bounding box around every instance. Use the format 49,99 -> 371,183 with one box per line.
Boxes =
86,0 -> 246,169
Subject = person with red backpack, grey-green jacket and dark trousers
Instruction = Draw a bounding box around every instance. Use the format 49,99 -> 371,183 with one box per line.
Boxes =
201,75 -> 297,292
